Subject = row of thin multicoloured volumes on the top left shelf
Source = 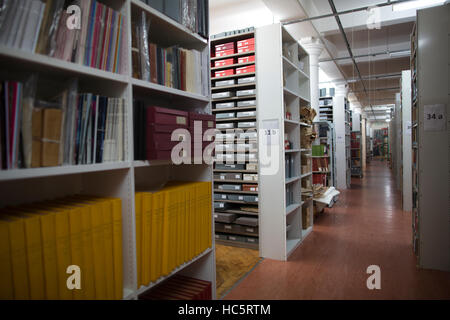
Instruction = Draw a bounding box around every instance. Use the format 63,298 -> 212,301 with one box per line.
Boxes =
0,0 -> 126,73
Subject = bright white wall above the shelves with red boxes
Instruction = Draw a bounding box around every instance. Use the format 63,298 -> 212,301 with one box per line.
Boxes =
209,0 -> 278,35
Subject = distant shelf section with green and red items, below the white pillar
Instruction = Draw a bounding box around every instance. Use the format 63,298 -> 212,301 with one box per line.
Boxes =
312,121 -> 336,187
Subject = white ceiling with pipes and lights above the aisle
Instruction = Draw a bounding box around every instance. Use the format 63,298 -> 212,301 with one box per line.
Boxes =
210,0 -> 442,121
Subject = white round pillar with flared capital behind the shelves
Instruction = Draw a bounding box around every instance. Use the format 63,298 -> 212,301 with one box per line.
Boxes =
300,37 -> 324,120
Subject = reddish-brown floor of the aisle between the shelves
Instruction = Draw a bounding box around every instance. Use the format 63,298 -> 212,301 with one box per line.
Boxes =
225,161 -> 450,299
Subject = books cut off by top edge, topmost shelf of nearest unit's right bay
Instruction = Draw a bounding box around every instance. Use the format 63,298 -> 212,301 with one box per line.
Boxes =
141,0 -> 209,38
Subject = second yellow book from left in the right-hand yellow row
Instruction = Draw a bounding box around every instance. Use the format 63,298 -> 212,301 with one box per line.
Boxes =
141,192 -> 152,286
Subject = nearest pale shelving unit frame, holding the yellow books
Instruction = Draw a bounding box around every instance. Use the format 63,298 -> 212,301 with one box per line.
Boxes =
0,0 -> 216,299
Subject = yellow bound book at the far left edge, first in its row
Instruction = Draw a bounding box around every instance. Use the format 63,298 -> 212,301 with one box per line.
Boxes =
0,220 -> 14,300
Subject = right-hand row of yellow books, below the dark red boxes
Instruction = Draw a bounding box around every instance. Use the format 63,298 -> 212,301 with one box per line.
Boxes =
135,182 -> 212,287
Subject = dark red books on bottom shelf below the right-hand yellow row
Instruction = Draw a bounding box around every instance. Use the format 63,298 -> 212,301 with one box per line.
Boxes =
139,275 -> 212,300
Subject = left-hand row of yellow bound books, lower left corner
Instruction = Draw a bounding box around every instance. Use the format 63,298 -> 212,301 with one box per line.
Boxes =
0,195 -> 123,300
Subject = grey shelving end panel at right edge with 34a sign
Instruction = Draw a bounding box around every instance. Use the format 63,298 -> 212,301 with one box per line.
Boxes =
411,5 -> 450,271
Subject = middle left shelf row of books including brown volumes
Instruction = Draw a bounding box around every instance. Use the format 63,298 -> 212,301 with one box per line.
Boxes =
0,80 -> 126,169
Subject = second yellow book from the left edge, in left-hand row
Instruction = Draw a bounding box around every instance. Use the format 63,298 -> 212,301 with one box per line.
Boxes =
0,215 -> 30,300
